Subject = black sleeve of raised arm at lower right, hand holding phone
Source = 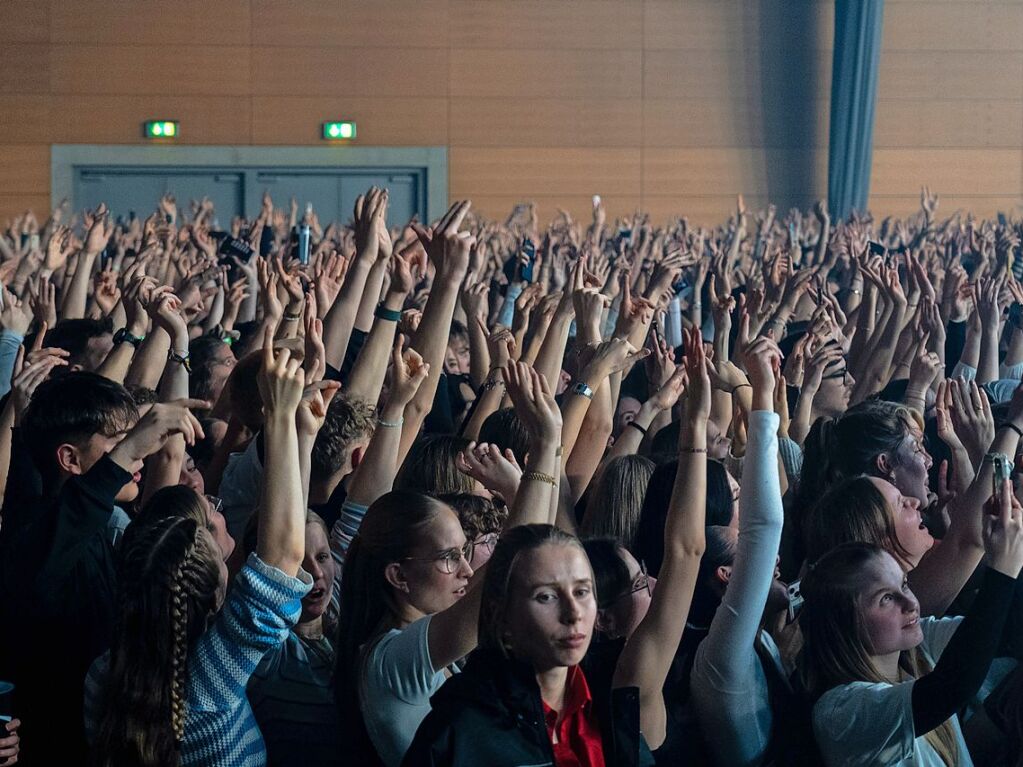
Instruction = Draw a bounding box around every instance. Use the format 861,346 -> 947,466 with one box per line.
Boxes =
913,570 -> 1016,737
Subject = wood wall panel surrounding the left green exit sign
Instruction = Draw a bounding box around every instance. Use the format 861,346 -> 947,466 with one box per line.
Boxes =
51,94 -> 253,144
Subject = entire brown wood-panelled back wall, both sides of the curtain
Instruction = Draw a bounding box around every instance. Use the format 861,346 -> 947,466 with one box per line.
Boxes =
0,0 -> 1023,223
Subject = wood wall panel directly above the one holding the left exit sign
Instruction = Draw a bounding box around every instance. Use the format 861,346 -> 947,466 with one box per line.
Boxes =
51,44 -> 250,96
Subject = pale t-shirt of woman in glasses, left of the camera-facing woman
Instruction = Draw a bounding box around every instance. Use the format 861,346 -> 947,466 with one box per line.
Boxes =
359,616 -> 457,767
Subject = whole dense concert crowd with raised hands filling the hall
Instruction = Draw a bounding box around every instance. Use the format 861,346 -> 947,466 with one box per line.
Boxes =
0,188 -> 1023,767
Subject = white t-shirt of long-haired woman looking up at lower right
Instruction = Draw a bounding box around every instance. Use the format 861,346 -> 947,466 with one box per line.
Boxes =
813,618 -> 973,767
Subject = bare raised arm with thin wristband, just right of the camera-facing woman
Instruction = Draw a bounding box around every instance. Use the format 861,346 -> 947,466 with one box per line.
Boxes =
614,328 -> 711,749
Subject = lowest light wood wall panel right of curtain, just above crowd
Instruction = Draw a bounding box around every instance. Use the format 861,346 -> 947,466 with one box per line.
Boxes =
871,148 -> 1023,196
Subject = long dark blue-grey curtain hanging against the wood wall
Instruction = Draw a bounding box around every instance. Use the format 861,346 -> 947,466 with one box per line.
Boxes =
828,0 -> 885,220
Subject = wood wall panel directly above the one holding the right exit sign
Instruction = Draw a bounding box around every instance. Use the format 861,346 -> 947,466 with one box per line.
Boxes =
252,47 -> 448,97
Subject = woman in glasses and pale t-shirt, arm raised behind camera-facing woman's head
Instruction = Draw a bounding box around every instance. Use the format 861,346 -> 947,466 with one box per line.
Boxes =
335,363 -> 562,766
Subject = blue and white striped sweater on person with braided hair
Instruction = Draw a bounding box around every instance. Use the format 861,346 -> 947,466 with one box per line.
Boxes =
85,553 -> 312,767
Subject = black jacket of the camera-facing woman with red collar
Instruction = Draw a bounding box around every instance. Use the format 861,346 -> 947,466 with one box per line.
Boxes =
402,649 -> 654,767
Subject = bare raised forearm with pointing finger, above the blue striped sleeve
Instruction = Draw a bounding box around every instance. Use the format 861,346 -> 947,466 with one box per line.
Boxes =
256,330 -> 306,578
